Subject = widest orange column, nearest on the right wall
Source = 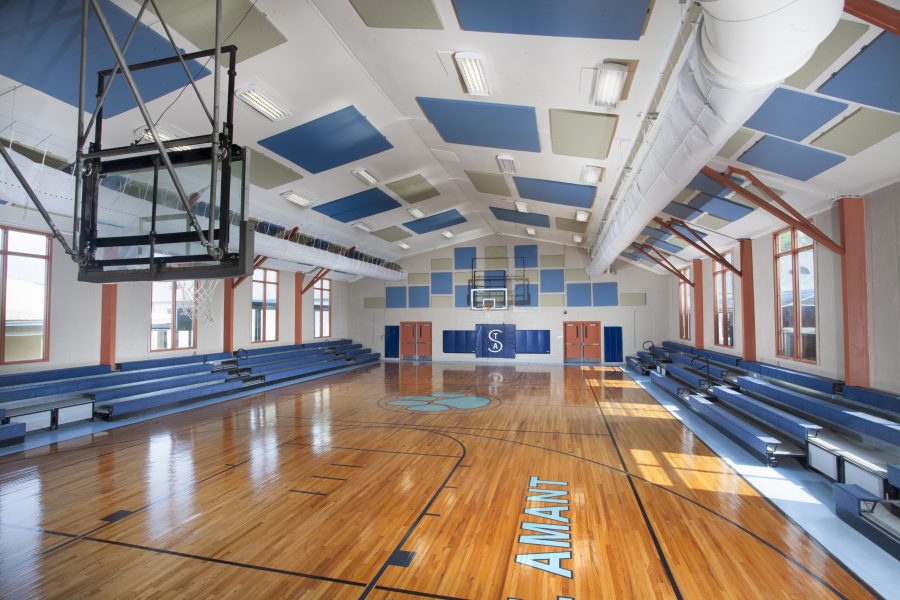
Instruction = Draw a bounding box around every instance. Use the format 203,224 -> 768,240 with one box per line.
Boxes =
838,198 -> 869,387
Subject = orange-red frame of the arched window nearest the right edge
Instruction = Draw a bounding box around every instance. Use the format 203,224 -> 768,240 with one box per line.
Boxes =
772,227 -> 819,365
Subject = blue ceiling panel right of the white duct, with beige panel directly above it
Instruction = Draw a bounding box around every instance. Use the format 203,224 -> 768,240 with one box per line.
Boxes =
744,88 -> 847,142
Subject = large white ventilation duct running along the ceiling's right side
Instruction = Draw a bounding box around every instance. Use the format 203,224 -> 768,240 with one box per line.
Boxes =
588,0 -> 844,275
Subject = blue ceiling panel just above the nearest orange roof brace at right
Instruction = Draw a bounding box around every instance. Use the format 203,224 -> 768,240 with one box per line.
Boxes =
738,135 -> 846,181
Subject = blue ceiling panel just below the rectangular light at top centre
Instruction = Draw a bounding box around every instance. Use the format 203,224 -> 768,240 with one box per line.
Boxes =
416,97 -> 541,152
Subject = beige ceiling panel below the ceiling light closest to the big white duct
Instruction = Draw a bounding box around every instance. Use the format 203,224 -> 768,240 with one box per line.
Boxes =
550,108 -> 619,159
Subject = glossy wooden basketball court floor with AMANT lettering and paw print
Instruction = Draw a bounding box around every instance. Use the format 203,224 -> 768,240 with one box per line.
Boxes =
0,363 -> 872,600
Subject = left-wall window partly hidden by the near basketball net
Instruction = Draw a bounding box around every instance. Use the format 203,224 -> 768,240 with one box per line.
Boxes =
150,281 -> 197,352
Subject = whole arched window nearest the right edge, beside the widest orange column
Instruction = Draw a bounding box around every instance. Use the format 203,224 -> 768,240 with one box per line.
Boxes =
773,228 -> 816,362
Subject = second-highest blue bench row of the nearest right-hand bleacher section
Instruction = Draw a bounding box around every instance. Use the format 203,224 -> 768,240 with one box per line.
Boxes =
737,377 -> 900,446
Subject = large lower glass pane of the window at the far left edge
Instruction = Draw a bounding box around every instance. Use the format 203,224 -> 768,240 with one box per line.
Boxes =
3,254 -> 47,362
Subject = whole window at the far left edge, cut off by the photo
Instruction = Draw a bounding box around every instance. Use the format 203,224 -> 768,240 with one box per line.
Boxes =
0,227 -> 50,364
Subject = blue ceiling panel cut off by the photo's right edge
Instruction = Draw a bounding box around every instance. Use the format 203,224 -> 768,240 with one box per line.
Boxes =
819,31 -> 900,112
